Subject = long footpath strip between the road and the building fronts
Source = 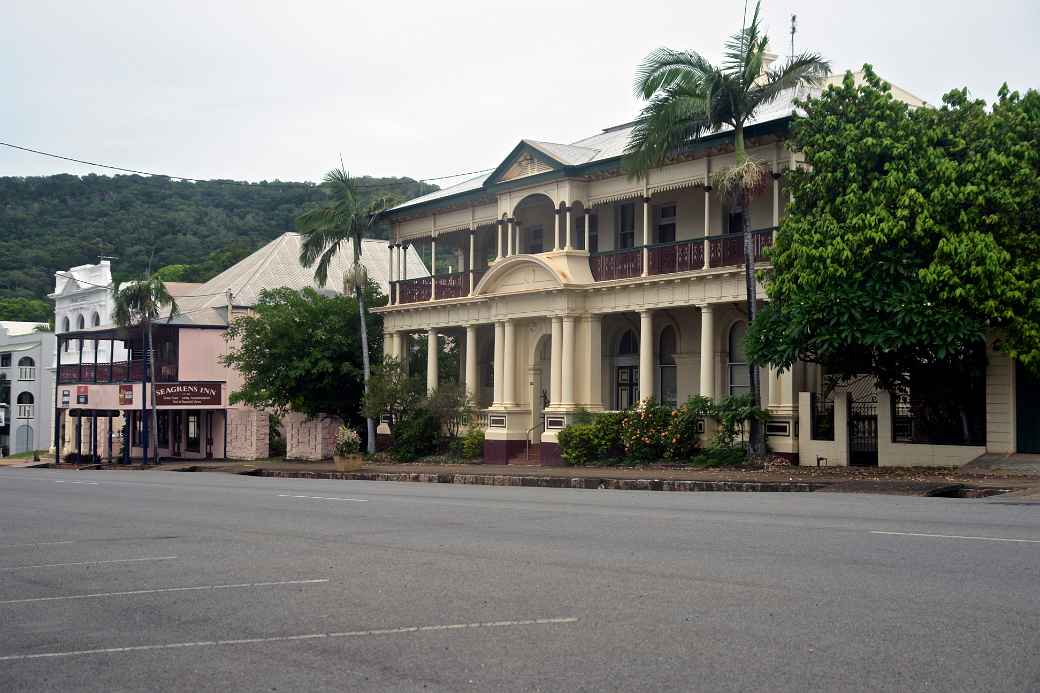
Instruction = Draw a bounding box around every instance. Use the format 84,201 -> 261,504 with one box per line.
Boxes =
26,459 -> 1040,499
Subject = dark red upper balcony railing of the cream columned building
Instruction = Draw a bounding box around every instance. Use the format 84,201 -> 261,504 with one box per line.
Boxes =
391,227 -> 776,304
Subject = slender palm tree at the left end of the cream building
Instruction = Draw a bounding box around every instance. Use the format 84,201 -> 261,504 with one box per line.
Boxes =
296,165 -> 394,454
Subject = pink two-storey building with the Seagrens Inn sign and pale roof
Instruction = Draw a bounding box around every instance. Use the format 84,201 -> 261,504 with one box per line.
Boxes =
55,233 -> 425,461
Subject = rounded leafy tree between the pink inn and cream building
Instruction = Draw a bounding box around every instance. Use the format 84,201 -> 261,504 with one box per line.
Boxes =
223,284 -> 383,426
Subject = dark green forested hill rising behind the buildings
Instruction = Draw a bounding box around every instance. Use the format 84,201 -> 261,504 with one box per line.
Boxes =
0,175 -> 437,320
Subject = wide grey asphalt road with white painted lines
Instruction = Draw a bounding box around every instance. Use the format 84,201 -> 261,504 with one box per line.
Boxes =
0,469 -> 1040,692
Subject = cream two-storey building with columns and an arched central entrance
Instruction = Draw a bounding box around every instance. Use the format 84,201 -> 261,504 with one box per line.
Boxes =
379,81 -> 1040,464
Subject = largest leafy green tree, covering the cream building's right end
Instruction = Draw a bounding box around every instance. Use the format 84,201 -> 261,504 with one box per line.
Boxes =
748,66 -> 1040,387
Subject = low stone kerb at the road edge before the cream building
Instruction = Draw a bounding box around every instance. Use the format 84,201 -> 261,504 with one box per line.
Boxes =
251,469 -> 828,493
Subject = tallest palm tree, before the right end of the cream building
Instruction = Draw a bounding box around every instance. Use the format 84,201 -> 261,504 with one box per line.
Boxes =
624,1 -> 830,455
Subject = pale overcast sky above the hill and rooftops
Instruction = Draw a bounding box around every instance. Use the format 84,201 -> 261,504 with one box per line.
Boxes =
0,0 -> 1040,184
